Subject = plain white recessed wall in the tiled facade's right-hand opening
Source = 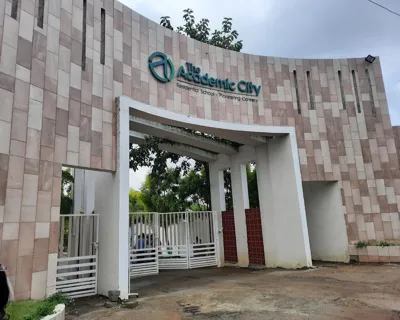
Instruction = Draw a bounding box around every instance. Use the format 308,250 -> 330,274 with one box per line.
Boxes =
303,182 -> 350,262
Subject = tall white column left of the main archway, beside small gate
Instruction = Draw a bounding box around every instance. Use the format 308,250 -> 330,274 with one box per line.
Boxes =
95,99 -> 129,299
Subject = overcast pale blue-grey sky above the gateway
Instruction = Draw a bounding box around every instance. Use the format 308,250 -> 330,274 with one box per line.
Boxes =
120,0 -> 400,189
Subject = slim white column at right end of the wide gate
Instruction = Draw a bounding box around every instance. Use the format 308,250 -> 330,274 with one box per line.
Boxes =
209,163 -> 226,267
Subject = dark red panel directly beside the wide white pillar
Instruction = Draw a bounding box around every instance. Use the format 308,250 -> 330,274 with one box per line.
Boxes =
246,209 -> 265,265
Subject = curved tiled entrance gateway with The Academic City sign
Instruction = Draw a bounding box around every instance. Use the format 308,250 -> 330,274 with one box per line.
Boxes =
0,0 -> 400,299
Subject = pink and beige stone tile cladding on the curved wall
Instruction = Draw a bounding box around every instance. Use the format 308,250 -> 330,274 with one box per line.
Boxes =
0,0 -> 400,299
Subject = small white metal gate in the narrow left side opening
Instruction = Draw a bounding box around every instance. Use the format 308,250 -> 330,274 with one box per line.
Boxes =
56,214 -> 99,298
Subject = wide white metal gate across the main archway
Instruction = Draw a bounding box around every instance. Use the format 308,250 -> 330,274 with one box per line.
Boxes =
129,211 -> 218,278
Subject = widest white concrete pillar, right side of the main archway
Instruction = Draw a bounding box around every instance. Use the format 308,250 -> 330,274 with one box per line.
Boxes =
256,132 -> 312,268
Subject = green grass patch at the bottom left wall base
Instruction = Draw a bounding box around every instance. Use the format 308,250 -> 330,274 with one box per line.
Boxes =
6,293 -> 71,320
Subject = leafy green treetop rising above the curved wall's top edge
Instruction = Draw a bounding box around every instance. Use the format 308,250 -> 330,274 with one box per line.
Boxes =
160,9 -> 243,52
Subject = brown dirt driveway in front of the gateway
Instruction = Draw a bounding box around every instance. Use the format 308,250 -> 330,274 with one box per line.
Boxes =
67,265 -> 400,320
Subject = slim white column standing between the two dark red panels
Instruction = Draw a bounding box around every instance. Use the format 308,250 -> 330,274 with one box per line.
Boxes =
231,160 -> 249,267
